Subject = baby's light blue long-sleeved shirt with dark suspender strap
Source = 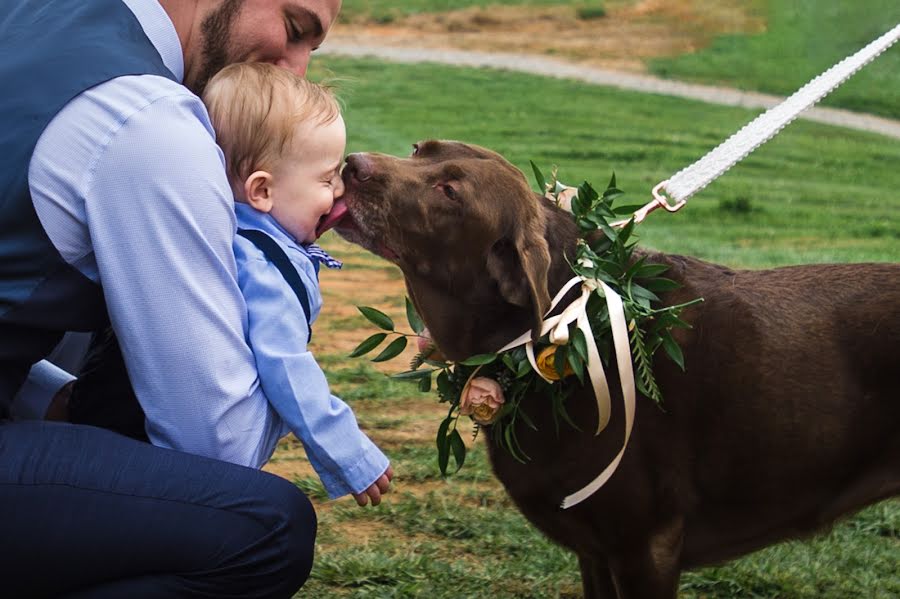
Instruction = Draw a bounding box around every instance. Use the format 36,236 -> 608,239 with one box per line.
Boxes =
234,203 -> 388,497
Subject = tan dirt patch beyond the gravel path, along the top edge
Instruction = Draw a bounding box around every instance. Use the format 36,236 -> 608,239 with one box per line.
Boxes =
329,0 -> 765,72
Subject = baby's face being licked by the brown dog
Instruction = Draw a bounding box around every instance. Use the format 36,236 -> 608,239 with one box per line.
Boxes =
271,116 -> 347,243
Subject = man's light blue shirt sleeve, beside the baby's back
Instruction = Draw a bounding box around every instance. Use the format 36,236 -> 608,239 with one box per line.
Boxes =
84,91 -> 280,467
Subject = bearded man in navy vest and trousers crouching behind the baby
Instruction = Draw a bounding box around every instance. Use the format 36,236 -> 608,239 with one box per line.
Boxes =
0,0 -> 385,597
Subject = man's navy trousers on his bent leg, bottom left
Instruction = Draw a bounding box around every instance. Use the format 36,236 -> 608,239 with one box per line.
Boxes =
0,421 -> 316,599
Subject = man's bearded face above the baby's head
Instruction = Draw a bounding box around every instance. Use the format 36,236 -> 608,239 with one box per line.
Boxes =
185,0 -> 341,94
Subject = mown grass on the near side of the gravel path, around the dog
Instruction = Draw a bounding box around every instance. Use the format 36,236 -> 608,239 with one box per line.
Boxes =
288,59 -> 900,599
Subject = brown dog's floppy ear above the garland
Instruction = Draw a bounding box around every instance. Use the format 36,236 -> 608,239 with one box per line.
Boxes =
487,211 -> 550,341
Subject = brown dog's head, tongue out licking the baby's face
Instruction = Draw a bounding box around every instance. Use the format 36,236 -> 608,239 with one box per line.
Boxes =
336,140 -> 571,358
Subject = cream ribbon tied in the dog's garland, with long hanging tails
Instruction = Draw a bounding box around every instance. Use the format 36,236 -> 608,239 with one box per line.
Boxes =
498,276 -> 635,509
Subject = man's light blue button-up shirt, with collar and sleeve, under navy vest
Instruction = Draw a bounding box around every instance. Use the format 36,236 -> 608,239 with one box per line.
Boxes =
21,0 -> 368,478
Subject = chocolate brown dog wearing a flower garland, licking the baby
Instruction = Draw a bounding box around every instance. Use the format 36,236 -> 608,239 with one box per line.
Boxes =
335,141 -> 900,599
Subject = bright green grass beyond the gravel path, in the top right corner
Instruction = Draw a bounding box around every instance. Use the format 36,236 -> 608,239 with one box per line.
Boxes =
649,0 -> 900,118
